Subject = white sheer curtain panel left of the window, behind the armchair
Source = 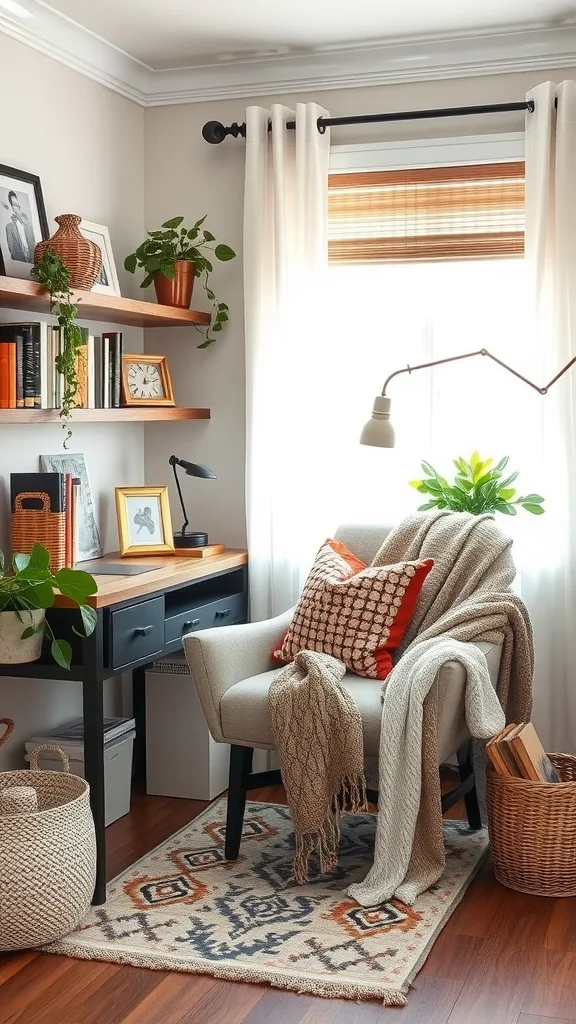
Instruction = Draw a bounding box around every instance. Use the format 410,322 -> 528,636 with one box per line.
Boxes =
244,103 -> 330,620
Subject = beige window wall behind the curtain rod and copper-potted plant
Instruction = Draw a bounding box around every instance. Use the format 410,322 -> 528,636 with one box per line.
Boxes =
145,68 -> 576,544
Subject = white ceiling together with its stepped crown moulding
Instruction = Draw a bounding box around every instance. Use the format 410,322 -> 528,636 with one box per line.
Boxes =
0,0 -> 576,106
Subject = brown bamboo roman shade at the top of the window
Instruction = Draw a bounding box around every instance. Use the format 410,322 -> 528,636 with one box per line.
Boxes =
328,161 -> 524,263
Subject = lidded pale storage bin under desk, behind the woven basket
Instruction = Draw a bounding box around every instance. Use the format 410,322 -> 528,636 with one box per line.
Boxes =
26,730 -> 135,825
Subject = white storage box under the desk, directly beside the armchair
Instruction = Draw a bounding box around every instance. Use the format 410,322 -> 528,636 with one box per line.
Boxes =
146,651 -> 230,800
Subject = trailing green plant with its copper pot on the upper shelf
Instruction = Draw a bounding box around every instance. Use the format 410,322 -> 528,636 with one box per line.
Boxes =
124,214 -> 236,348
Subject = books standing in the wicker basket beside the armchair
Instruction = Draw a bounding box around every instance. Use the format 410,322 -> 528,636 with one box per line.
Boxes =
486,722 -> 562,782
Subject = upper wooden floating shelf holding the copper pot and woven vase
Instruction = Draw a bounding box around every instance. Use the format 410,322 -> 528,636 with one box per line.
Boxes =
0,276 -> 210,327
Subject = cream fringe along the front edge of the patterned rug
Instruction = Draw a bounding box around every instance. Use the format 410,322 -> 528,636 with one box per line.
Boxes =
42,939 -> 408,1007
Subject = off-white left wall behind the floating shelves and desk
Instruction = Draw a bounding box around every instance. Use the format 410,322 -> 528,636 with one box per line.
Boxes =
0,35 -> 143,770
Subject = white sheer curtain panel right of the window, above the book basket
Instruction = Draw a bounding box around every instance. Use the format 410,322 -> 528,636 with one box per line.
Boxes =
521,81 -> 576,752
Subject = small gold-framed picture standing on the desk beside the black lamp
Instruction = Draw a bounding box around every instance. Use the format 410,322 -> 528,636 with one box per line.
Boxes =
116,486 -> 174,555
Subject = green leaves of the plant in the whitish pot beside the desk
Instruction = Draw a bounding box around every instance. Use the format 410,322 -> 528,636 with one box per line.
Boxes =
0,544 -> 98,669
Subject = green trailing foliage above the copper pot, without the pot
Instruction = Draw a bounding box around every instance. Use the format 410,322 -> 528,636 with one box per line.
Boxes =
124,214 -> 236,348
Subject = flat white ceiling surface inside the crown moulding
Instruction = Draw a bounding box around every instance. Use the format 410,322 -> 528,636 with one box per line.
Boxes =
39,0 -> 576,71
